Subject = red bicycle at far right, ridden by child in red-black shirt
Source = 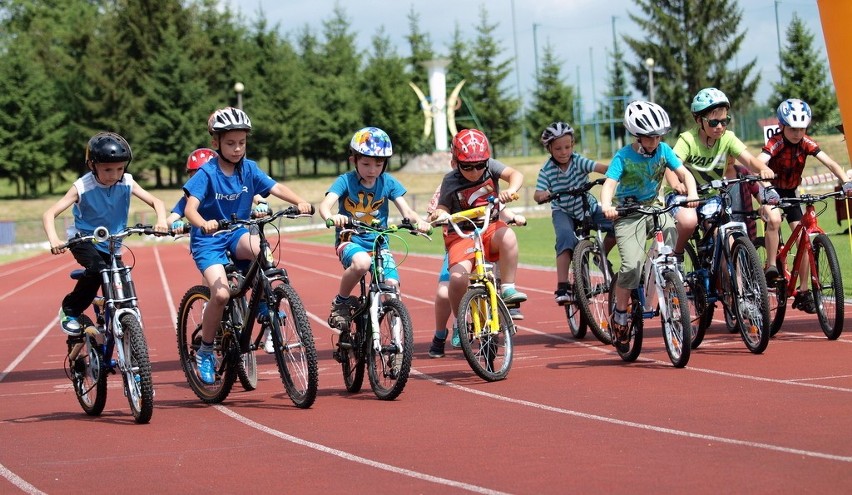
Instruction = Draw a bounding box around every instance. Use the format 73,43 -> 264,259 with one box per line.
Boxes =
755,191 -> 844,340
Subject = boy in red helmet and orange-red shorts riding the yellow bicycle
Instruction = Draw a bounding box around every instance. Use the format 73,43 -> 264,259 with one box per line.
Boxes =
433,129 -> 527,336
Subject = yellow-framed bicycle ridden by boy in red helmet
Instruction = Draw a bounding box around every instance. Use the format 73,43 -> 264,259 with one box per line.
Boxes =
448,197 -> 516,382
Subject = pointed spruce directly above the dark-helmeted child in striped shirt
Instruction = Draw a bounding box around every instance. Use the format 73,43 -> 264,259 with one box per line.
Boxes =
526,42 -> 579,146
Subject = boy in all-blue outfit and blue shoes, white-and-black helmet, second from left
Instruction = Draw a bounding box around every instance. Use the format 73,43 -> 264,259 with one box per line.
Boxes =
183,107 -> 311,385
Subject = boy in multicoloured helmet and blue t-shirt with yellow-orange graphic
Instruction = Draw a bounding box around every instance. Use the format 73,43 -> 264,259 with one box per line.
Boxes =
319,127 -> 430,342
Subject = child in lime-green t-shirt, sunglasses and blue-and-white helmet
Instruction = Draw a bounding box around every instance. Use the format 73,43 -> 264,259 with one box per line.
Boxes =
665,88 -> 774,268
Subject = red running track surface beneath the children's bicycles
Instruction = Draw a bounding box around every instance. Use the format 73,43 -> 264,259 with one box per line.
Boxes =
0,238 -> 852,494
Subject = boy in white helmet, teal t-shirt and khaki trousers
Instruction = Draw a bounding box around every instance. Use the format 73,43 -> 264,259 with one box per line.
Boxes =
601,101 -> 698,345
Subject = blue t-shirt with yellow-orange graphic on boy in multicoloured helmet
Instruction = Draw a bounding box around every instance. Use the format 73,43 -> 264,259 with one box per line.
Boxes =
326,171 -> 407,250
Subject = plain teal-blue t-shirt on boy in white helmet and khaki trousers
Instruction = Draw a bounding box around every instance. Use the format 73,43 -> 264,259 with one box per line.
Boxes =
606,142 -> 682,203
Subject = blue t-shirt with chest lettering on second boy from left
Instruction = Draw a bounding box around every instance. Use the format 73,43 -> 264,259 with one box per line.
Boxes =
183,157 -> 276,238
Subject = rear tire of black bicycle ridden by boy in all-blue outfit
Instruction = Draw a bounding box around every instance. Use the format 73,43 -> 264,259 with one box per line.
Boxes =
177,285 -> 238,404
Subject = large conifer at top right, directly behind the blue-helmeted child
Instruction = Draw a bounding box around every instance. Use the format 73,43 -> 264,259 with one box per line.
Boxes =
623,0 -> 760,132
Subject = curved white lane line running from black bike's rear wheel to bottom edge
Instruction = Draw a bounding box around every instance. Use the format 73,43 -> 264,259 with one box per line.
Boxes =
213,405 -> 505,495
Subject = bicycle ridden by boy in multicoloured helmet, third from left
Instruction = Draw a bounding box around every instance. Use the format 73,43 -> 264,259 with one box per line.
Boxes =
326,218 -> 431,400
